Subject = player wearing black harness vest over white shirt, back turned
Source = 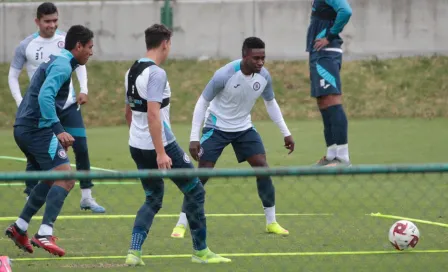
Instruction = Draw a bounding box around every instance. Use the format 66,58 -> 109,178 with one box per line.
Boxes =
125,24 -> 231,266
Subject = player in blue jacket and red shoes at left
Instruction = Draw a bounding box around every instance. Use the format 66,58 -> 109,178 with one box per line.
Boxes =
5,25 -> 93,256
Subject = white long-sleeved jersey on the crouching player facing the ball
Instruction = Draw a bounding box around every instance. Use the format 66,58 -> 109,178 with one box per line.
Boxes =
190,60 -> 291,141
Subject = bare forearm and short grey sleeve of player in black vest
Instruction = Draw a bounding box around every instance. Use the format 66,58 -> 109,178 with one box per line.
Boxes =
147,69 -> 172,169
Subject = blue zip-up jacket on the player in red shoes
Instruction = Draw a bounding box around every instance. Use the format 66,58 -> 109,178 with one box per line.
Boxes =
14,49 -> 78,135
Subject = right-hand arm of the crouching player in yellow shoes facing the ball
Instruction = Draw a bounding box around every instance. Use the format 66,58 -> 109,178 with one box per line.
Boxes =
261,71 -> 294,153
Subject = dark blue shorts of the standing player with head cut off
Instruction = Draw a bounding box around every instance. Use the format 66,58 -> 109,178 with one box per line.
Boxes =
309,50 -> 342,97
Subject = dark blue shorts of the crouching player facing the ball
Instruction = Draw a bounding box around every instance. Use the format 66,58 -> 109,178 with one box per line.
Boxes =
199,128 -> 266,163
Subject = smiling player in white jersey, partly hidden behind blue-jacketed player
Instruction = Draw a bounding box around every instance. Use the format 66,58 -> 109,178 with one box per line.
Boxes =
8,2 -> 105,213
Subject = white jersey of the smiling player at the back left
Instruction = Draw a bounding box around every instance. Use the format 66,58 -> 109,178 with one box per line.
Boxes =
8,30 -> 88,109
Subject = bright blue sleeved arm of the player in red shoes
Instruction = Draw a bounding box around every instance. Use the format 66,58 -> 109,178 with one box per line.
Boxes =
38,62 -> 74,147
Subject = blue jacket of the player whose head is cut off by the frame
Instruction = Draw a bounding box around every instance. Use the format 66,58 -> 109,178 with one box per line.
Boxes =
306,0 -> 352,52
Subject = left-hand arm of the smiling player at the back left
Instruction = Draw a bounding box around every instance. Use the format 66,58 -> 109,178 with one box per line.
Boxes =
8,44 -> 26,107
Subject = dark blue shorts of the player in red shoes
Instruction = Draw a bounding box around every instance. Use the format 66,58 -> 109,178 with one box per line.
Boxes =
14,126 -> 70,171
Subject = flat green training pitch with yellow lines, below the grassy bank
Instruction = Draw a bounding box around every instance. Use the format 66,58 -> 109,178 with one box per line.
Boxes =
0,119 -> 448,271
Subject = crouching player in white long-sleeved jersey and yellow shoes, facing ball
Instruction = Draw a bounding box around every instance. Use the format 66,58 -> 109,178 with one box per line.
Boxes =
171,37 -> 294,238
